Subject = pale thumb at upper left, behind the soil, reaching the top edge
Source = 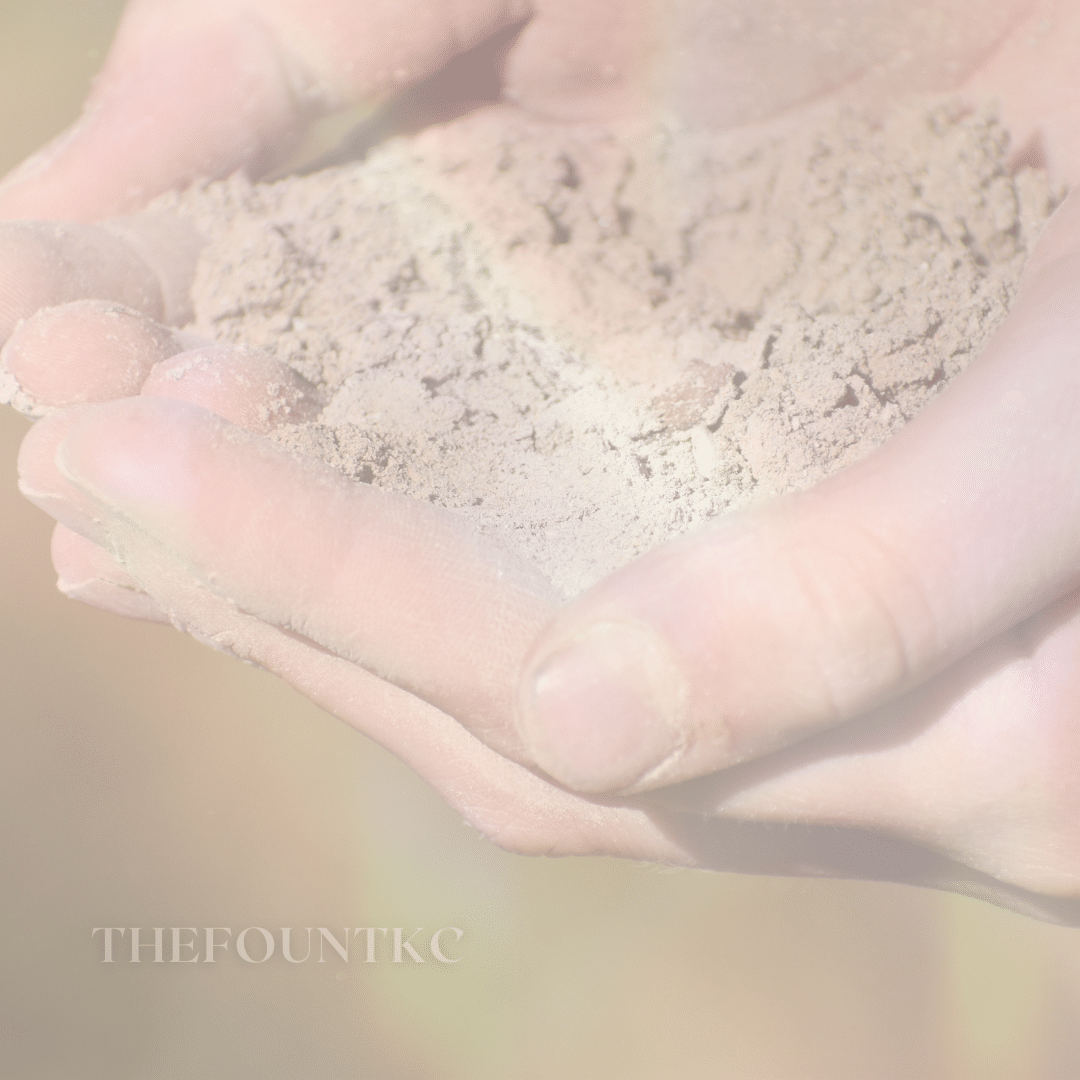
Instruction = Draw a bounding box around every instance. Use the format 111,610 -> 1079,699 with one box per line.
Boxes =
0,0 -> 527,221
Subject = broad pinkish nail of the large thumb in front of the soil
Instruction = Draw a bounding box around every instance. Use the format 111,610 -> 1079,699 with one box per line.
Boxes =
519,623 -> 688,794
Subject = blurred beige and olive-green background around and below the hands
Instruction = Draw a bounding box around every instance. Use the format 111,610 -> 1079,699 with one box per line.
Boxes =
0,0 -> 1080,1080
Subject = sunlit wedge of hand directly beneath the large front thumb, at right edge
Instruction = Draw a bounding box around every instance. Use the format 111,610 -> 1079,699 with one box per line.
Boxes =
648,594 -> 1080,897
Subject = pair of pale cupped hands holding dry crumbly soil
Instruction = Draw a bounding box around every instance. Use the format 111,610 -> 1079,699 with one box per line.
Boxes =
6,0 -> 1080,921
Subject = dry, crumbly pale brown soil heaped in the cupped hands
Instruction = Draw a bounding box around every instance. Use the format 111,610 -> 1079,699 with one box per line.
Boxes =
167,103 -> 1054,594
